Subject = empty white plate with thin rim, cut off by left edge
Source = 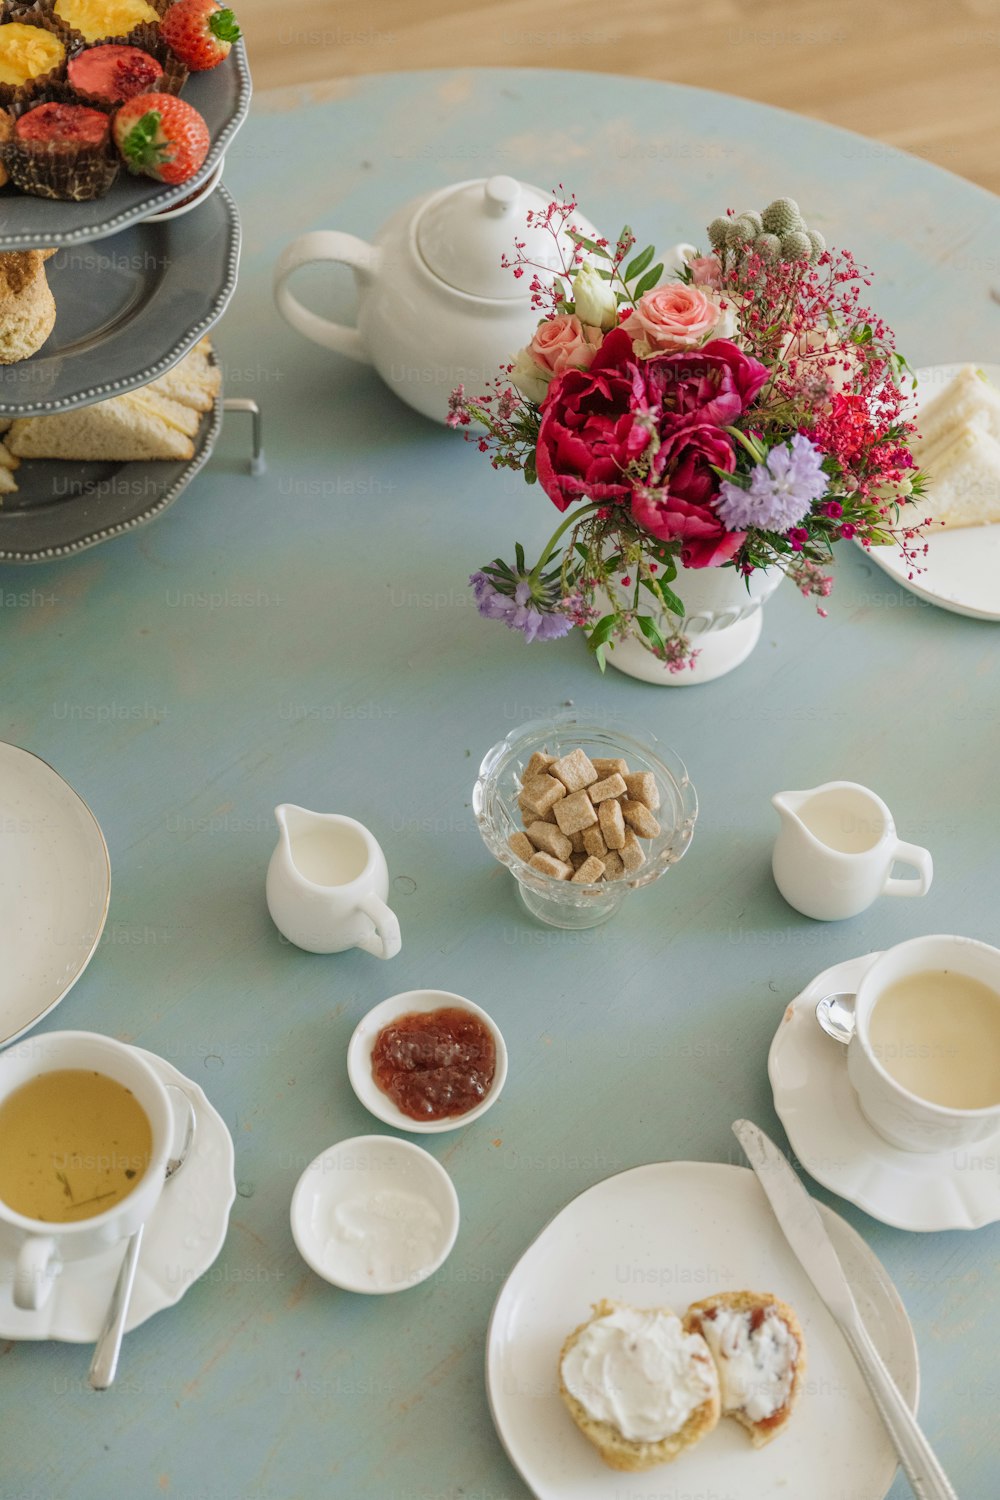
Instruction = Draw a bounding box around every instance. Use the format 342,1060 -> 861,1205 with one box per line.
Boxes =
0,741 -> 111,1047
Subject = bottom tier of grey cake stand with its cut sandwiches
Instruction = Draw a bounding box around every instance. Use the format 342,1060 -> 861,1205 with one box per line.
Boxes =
0,339 -> 222,563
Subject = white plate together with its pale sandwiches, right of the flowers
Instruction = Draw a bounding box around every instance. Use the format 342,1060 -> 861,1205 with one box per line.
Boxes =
868,365 -> 1000,620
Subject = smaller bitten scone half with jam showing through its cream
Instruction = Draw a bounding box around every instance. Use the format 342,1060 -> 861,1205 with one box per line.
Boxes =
684,1292 -> 805,1448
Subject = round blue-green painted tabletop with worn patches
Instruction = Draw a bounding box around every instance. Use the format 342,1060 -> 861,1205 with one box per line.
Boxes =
0,71 -> 1000,1500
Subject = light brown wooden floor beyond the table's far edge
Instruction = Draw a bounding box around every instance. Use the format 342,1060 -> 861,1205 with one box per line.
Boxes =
239,0 -> 1000,192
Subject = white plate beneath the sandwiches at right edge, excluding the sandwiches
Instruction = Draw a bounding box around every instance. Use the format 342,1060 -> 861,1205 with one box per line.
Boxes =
865,360 -> 1000,620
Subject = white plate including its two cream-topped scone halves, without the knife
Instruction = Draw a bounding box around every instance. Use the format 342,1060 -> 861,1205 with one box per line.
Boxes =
486,1161 -> 919,1500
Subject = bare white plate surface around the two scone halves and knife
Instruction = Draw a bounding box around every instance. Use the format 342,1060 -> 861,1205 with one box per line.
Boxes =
486,1161 -> 919,1500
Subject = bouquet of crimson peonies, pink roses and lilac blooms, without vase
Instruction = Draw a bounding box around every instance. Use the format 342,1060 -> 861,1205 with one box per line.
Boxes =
448,198 -> 921,672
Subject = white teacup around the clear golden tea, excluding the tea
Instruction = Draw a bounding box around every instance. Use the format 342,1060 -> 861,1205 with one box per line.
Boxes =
0,1032 -> 174,1310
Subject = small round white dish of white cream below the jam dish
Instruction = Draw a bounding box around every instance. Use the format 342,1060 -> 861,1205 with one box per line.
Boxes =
291,1136 -> 459,1296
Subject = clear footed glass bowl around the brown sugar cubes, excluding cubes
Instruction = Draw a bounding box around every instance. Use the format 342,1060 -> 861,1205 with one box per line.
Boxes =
472,713 -> 697,929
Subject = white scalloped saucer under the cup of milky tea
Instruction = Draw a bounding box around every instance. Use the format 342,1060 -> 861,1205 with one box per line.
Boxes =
768,953 -> 1000,1232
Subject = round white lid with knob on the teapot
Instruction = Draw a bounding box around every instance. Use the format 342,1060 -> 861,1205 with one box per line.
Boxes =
415,176 -> 569,302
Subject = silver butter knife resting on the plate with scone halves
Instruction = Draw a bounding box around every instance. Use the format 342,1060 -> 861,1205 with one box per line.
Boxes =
733,1121 -> 958,1500
